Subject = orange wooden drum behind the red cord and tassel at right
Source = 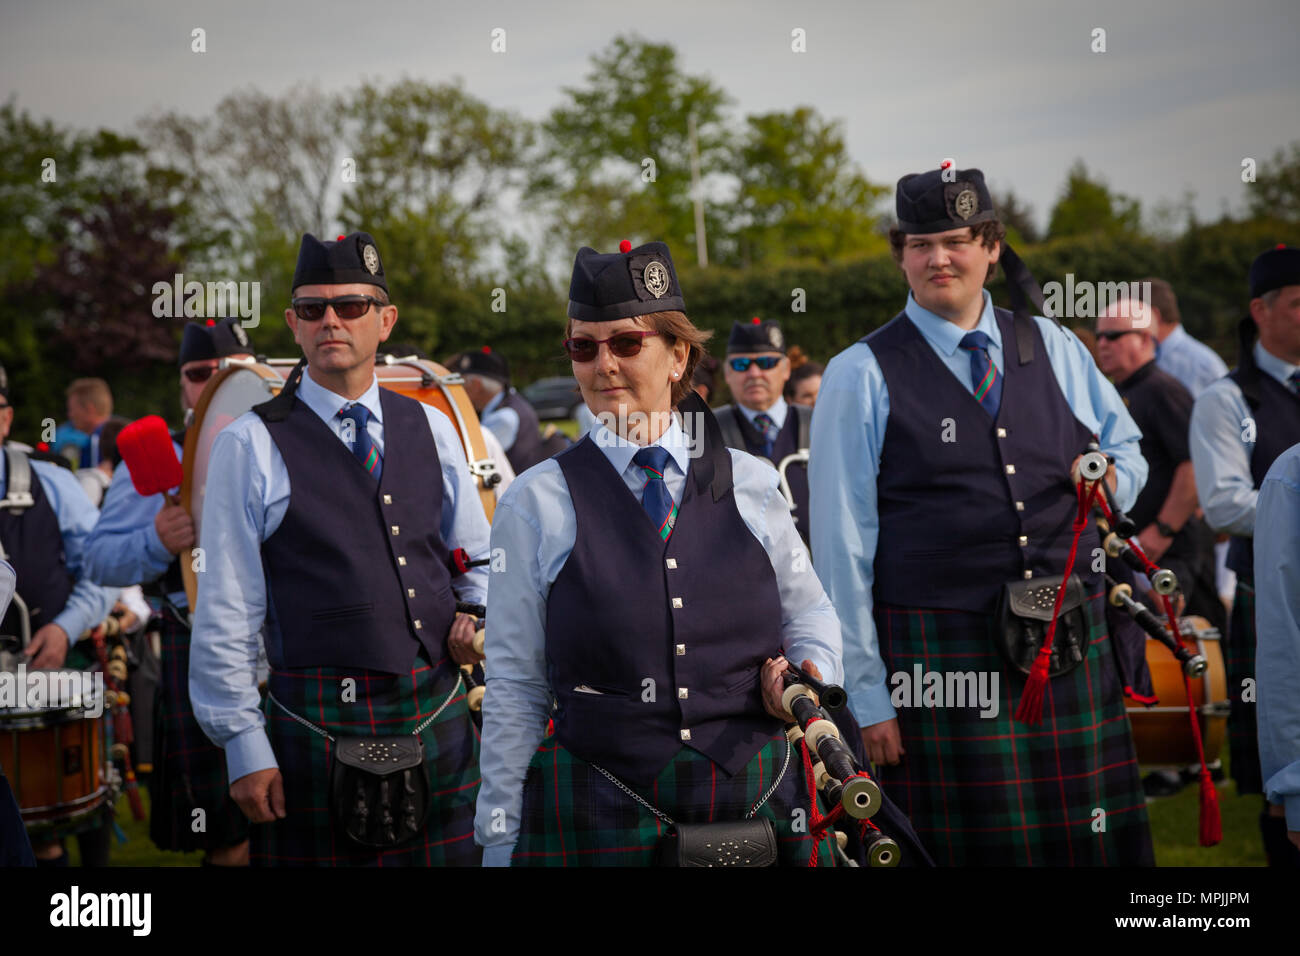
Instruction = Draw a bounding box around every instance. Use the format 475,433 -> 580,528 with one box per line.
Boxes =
1127,617 -> 1229,766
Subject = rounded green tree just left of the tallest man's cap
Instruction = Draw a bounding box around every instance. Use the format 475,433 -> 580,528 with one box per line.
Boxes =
731,107 -> 888,265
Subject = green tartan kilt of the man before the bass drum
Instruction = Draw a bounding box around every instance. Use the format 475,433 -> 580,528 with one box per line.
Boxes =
250,654 -> 482,866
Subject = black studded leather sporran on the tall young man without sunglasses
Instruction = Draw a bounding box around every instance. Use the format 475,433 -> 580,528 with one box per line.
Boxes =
993,575 -> 1088,678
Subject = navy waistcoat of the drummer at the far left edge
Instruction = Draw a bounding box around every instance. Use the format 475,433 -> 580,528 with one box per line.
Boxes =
0,450 -> 73,640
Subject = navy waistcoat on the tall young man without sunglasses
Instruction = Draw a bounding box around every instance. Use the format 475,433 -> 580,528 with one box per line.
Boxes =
862,308 -> 1100,614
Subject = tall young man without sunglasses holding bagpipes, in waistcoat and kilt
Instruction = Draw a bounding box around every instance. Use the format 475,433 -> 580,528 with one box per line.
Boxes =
810,169 -> 1152,866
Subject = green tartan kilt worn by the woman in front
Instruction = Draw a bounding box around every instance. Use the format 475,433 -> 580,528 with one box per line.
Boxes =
511,734 -> 837,866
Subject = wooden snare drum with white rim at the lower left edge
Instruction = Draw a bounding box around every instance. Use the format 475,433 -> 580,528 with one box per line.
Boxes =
0,670 -> 111,830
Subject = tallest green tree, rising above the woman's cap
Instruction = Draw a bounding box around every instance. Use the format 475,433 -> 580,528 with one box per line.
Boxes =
530,36 -> 728,261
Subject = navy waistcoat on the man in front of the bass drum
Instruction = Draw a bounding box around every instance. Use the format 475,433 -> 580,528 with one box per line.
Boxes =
261,389 -> 456,674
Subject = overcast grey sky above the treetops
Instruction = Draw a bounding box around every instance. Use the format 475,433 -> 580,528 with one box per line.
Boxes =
0,0 -> 1300,234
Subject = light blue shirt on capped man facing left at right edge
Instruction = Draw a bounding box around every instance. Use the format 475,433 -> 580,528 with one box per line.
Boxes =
1187,342 -> 1300,537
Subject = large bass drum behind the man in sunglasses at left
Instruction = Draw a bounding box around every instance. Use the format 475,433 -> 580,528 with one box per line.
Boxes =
181,355 -> 501,607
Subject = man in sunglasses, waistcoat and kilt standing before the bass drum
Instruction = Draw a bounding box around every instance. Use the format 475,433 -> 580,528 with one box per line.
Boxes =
190,233 -> 489,866
